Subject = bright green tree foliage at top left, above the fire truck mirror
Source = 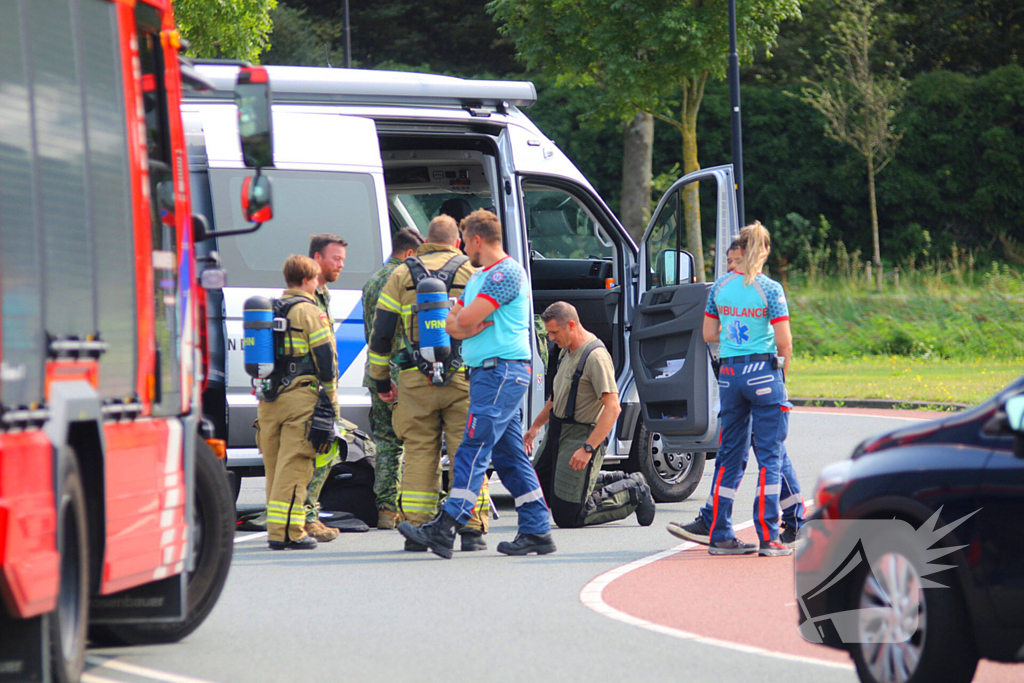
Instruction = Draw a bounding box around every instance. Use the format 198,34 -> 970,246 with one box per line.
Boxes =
174,0 -> 278,62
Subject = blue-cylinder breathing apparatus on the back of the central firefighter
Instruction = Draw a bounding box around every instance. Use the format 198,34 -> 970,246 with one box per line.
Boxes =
406,254 -> 469,386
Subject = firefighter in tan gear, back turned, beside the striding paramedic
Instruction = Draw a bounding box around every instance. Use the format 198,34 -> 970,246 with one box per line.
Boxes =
369,215 -> 490,552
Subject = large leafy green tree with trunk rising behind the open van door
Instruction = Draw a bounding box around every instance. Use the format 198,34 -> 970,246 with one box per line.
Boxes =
487,0 -> 800,280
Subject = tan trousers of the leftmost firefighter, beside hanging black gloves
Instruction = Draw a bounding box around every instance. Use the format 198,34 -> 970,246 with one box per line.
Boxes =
256,385 -> 317,541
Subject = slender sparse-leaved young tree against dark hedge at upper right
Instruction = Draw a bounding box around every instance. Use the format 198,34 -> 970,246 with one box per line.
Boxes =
801,0 -> 906,290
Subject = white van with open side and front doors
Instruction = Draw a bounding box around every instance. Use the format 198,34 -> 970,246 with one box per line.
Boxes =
182,65 -> 738,502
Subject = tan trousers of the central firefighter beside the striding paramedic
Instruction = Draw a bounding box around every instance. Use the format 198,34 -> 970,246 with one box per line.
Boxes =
391,369 -> 490,532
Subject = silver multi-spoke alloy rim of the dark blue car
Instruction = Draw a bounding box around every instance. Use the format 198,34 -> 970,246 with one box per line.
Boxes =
858,553 -> 927,683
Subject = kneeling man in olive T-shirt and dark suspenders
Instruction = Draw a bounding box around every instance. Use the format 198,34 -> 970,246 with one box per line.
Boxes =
523,301 -> 654,528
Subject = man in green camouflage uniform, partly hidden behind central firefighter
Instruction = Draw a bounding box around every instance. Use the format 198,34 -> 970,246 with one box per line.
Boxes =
362,227 -> 423,528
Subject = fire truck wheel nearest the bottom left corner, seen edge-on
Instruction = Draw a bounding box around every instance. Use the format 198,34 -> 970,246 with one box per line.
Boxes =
49,446 -> 89,683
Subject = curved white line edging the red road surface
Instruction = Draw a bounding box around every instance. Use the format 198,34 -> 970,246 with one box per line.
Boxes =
580,519 -> 853,671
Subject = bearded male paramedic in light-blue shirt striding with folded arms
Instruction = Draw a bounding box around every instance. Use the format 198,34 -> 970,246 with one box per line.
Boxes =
398,209 -> 555,558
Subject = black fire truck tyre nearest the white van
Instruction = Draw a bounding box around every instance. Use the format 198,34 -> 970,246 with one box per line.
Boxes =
89,437 -> 234,645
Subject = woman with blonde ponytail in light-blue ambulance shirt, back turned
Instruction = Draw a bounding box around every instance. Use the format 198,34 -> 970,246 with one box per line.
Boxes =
703,221 -> 793,556
